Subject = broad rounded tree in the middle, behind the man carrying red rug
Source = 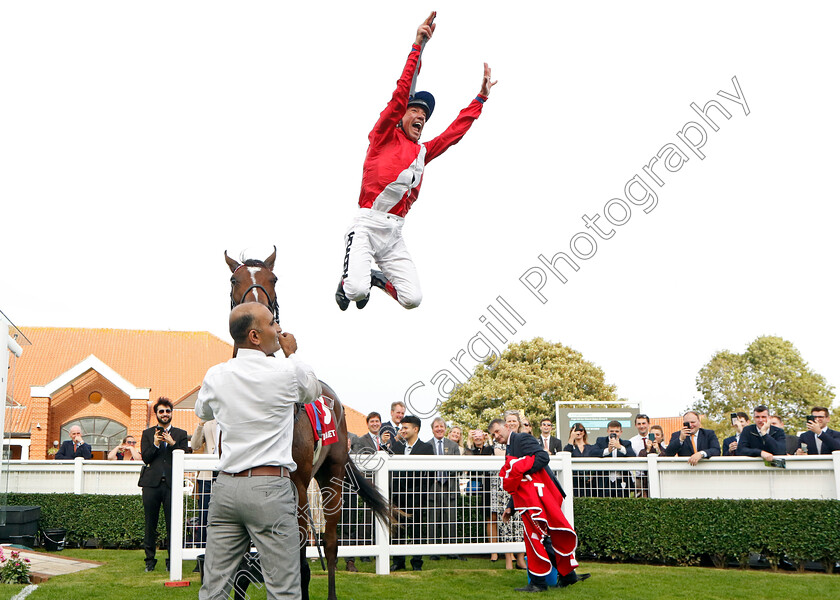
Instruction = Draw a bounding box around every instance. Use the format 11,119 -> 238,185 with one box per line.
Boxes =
440,338 -> 618,431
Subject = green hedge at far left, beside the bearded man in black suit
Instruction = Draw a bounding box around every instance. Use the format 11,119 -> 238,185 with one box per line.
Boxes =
6,493 -> 185,548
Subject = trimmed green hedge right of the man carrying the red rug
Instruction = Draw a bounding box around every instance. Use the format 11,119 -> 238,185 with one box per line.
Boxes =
575,498 -> 840,572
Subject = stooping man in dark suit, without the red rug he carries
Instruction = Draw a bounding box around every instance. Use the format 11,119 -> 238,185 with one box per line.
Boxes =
489,419 -> 589,592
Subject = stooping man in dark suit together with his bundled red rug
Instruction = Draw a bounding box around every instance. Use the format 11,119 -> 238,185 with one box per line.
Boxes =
489,419 -> 590,592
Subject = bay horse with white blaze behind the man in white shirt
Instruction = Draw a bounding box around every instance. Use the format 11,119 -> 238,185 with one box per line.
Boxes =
225,246 -> 398,600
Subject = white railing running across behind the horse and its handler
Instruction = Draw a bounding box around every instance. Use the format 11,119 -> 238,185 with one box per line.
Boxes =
3,451 -> 840,579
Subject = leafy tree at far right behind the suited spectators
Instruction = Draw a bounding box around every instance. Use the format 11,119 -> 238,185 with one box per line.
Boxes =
692,336 -> 834,435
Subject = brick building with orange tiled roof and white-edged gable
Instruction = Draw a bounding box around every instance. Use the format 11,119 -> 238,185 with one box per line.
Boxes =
5,327 -> 367,460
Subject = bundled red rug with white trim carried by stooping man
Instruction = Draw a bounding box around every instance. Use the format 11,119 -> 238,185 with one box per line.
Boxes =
499,456 -> 577,575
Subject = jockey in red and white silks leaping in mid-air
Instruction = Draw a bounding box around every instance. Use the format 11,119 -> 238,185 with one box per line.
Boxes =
335,12 -> 496,310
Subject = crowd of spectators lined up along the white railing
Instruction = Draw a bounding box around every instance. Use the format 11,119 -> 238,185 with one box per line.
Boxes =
49,400 -> 840,571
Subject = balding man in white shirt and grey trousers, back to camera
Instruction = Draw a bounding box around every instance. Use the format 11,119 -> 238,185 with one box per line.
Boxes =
195,302 -> 321,600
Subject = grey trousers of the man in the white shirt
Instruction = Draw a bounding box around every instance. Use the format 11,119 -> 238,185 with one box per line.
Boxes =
198,473 -> 301,600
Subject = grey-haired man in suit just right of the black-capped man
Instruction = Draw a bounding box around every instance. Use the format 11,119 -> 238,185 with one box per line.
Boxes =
427,417 -> 466,560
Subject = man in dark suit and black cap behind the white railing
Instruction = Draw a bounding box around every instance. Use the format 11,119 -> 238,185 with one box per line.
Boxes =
391,415 -> 435,571
